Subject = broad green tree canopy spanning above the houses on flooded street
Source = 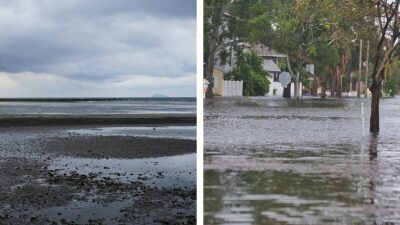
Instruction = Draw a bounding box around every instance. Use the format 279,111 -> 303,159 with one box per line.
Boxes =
204,0 -> 382,98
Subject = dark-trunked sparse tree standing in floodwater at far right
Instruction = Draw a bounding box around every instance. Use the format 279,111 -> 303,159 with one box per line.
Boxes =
369,0 -> 400,133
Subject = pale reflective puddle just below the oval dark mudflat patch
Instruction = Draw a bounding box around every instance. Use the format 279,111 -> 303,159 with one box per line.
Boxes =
48,154 -> 196,188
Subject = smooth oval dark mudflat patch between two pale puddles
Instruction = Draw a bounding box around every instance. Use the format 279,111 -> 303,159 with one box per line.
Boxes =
35,136 -> 196,158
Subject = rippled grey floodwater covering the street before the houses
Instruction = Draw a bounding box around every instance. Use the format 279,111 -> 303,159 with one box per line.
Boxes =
204,97 -> 400,225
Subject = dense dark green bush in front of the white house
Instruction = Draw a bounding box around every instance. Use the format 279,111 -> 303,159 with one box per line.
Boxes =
225,52 -> 270,96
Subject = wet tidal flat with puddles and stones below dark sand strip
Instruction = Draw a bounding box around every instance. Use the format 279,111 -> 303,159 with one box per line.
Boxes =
0,117 -> 196,224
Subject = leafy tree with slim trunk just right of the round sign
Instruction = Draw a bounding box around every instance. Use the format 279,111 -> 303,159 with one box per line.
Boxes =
274,0 -> 337,99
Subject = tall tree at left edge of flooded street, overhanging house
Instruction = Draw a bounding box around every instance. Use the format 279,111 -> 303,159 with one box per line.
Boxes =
203,0 -> 271,97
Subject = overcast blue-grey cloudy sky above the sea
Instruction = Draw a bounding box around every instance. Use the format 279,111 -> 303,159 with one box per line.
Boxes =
0,0 -> 196,97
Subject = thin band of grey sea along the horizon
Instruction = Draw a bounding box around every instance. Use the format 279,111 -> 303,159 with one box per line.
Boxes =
0,97 -> 196,115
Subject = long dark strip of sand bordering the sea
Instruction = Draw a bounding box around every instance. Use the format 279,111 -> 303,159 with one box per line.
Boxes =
0,113 -> 196,127
